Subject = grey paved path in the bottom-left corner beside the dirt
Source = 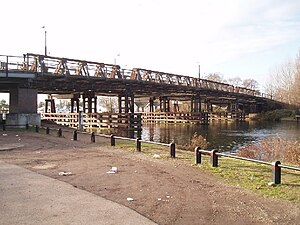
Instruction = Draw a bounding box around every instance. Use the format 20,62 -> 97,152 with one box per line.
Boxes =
0,161 -> 155,225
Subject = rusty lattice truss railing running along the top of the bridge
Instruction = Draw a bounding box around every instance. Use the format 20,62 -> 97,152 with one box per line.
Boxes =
0,53 -> 270,98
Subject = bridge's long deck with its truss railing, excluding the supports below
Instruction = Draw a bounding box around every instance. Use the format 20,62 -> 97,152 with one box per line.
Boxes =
0,53 -> 268,103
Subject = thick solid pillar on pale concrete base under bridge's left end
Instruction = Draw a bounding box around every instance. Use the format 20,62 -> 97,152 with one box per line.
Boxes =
6,88 -> 41,127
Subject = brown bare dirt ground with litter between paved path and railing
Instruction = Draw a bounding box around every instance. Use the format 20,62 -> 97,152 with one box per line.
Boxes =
0,128 -> 300,225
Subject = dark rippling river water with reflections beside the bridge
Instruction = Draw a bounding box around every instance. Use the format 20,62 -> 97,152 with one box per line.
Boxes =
118,121 -> 300,151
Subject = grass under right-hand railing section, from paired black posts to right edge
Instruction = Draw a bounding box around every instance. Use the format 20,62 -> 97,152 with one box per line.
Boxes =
200,156 -> 300,203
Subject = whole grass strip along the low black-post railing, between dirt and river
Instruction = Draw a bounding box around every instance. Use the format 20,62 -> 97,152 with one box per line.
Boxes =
106,140 -> 300,203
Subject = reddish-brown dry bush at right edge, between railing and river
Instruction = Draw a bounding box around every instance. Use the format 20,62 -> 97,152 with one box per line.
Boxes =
237,137 -> 300,166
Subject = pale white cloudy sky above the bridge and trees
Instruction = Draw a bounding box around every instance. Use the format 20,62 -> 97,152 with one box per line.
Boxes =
0,0 -> 300,101
